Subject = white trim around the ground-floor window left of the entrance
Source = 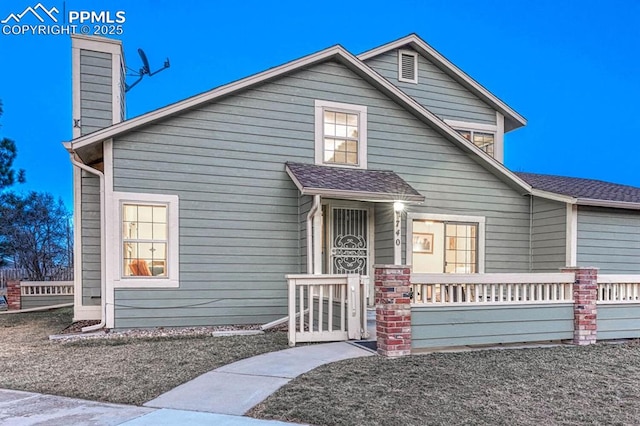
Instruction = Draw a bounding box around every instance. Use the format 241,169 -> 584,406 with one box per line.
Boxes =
111,192 -> 180,288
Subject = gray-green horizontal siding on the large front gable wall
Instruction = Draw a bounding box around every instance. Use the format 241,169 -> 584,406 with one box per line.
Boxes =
113,59 -> 529,327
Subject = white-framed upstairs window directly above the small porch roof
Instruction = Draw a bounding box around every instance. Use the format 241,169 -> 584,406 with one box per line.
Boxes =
315,100 -> 367,168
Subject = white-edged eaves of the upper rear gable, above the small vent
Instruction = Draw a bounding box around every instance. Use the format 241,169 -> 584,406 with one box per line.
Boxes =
358,34 -> 527,131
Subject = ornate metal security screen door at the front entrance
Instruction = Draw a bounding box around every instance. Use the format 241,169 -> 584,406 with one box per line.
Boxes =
330,207 -> 369,275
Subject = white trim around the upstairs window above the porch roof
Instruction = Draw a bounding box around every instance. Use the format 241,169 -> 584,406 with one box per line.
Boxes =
314,99 -> 367,169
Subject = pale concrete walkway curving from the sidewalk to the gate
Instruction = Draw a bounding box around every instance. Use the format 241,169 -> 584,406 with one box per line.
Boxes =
0,342 -> 373,426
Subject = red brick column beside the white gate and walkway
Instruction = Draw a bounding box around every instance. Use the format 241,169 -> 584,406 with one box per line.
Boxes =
374,265 -> 411,358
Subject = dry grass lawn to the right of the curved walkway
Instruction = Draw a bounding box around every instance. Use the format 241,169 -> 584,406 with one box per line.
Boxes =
250,343 -> 640,425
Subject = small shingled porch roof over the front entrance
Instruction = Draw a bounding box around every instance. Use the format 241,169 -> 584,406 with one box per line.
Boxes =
285,162 -> 424,203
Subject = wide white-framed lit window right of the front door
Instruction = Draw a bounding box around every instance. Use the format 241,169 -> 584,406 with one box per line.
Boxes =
407,213 -> 485,274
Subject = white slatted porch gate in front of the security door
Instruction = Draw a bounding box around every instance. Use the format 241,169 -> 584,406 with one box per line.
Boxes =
287,275 -> 366,346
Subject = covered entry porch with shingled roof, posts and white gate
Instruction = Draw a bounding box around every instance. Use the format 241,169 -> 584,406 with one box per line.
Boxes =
286,163 -> 424,345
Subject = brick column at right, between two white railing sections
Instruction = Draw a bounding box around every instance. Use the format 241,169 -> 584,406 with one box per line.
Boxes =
562,267 -> 598,345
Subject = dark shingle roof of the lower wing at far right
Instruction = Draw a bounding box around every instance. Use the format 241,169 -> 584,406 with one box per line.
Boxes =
516,173 -> 640,203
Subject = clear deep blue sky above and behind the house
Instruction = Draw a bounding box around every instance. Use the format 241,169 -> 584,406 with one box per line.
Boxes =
0,0 -> 640,207
